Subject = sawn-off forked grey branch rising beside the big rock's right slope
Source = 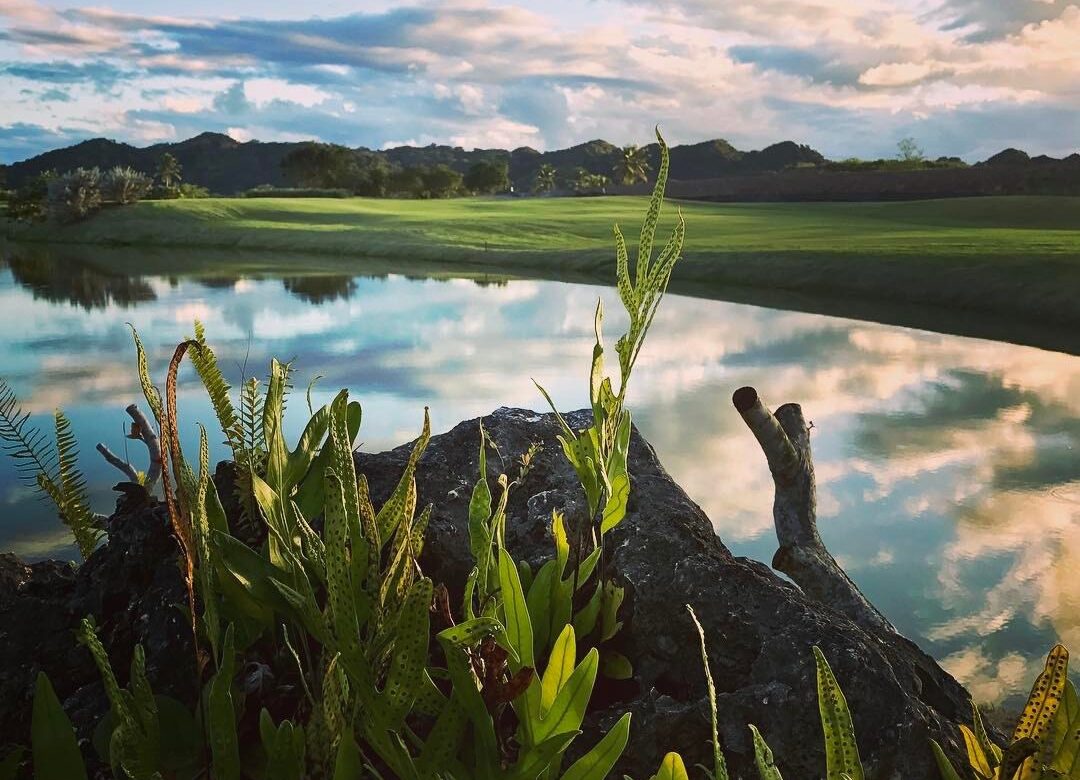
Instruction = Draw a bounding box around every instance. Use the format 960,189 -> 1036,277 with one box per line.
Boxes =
731,387 -> 896,633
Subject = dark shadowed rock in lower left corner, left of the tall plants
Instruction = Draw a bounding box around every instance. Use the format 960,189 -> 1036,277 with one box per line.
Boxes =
0,483 -> 195,756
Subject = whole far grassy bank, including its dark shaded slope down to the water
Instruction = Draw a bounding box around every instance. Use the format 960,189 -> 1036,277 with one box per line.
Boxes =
5,198 -> 1080,354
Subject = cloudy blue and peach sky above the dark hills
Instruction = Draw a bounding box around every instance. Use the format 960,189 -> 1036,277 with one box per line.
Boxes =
0,0 -> 1080,162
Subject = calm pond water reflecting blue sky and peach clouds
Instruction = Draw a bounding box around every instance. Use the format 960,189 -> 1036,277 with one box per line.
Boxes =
0,244 -> 1080,701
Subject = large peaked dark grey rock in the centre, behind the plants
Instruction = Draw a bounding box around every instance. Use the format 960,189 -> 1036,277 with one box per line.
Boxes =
356,408 -> 971,780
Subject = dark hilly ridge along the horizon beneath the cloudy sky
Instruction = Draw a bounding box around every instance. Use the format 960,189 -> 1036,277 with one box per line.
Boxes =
0,133 -> 1080,200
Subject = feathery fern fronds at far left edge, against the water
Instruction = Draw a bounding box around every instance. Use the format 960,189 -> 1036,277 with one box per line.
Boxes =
0,379 -> 104,560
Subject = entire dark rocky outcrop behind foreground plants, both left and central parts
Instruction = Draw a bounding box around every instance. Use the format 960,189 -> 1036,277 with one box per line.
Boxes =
0,408 -> 970,780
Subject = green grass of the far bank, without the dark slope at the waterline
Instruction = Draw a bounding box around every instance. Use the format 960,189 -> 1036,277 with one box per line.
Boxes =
10,197 -> 1080,330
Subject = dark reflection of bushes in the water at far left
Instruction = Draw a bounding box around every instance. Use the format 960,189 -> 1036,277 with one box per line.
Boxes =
4,252 -> 158,311
